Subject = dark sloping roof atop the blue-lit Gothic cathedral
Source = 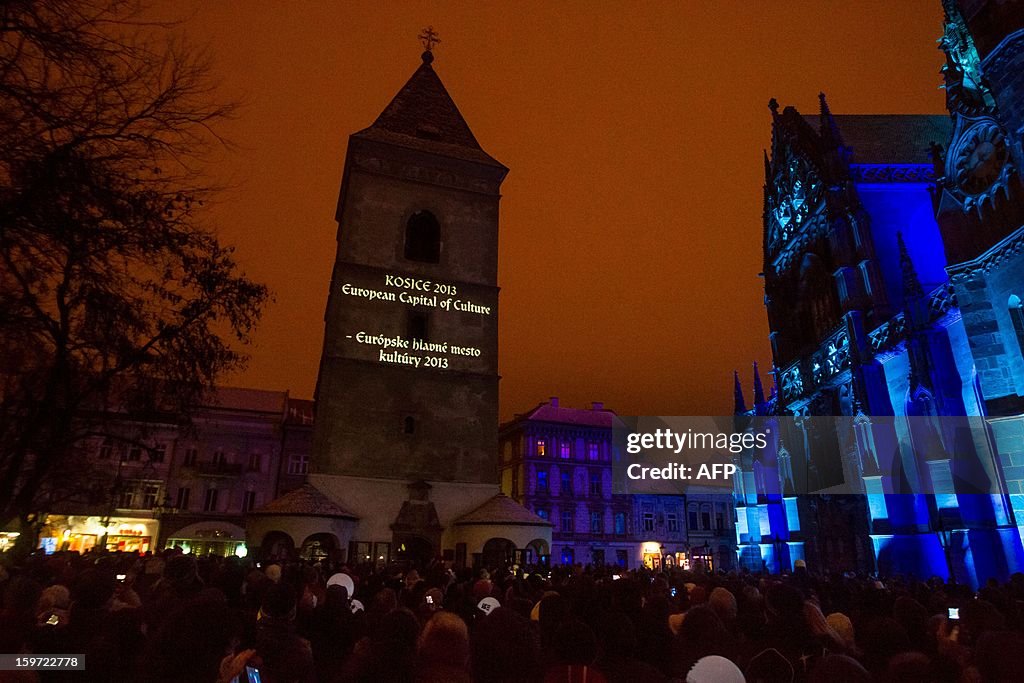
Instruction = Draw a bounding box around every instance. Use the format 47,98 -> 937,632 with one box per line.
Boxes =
804,114 -> 952,164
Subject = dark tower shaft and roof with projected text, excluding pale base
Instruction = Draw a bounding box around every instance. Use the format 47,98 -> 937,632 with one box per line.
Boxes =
312,51 -> 508,483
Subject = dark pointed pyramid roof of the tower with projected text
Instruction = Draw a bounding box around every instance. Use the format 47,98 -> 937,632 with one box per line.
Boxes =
353,53 -> 505,168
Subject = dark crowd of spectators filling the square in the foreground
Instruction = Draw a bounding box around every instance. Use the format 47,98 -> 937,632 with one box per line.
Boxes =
0,551 -> 1024,683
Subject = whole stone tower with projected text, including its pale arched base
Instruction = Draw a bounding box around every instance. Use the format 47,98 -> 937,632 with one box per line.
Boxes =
251,41 -> 551,563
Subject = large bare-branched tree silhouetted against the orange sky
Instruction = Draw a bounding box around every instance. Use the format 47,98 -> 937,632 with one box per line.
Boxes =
0,0 -> 268,548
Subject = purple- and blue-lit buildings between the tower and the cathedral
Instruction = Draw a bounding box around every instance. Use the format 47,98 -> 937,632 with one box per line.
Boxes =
499,396 -> 734,568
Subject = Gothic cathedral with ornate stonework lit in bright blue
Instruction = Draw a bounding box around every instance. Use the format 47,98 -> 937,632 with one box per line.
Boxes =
734,0 -> 1024,586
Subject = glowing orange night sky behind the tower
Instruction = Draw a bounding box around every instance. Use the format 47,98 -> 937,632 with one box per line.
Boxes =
164,0 -> 944,419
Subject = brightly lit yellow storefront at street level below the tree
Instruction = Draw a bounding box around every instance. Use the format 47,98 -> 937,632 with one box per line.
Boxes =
38,515 -> 160,553
